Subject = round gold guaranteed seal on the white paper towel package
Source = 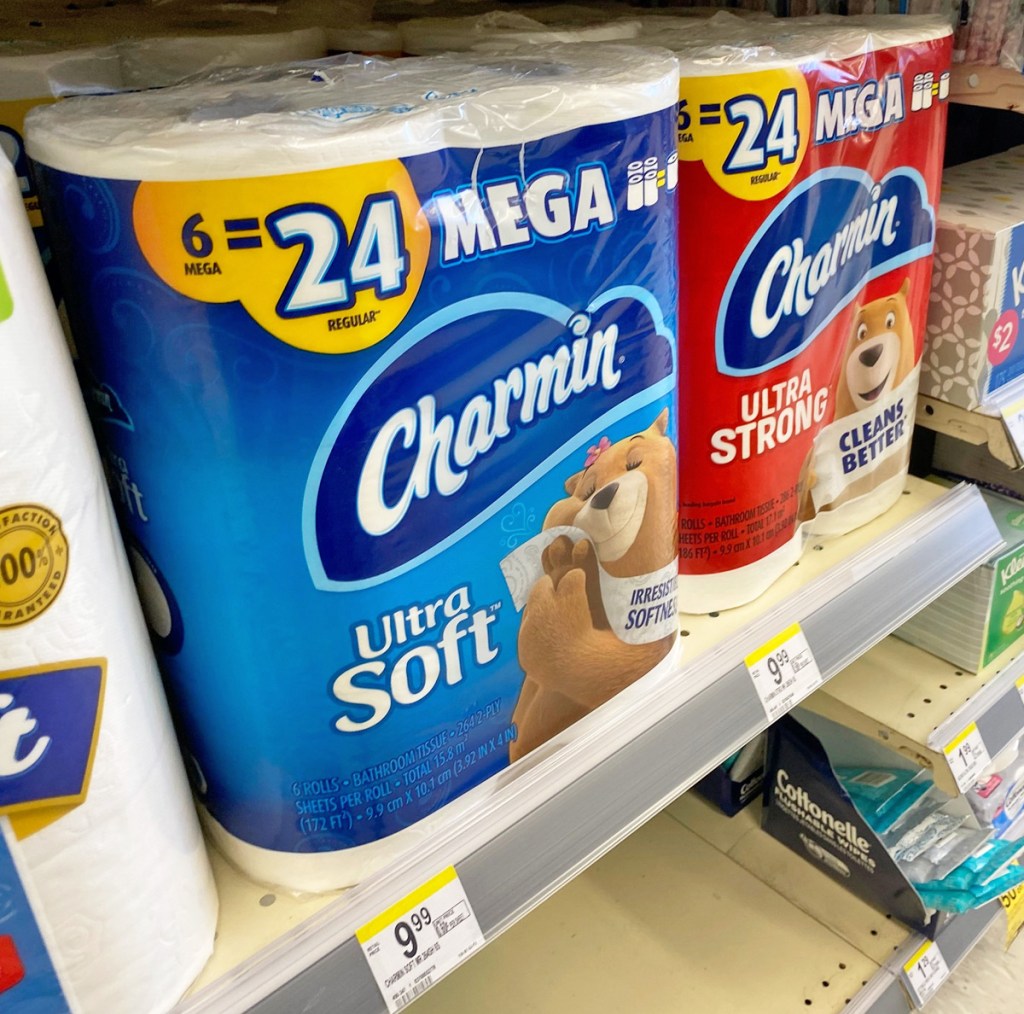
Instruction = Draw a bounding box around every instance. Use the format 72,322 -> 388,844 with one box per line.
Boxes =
0,504 -> 68,627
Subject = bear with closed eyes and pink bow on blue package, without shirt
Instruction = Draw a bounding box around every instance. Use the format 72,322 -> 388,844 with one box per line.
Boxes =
509,409 -> 678,761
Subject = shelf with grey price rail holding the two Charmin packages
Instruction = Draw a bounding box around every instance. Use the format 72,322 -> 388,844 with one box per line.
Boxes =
179,479 -> 999,1014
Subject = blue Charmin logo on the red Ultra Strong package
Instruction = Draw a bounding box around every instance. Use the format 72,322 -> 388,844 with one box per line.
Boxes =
715,168 -> 935,376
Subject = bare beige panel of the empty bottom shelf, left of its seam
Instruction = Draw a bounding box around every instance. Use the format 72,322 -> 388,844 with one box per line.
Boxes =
413,813 -> 878,1014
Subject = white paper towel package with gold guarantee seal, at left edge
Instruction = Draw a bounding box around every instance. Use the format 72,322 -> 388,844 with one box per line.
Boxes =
0,156 -> 216,1014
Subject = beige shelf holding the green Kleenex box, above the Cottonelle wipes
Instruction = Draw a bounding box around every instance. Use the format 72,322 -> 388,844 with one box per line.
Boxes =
804,637 -> 1024,796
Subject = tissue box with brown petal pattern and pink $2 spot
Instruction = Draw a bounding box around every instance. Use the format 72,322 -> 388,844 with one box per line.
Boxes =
921,146 -> 1024,409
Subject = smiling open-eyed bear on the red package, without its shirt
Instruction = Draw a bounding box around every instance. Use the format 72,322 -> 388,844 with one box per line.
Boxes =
798,279 -> 918,521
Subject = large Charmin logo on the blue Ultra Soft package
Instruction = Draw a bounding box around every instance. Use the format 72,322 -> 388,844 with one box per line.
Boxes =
303,286 -> 674,591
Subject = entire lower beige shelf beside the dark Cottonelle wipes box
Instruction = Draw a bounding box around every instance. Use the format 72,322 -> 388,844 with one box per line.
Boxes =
405,795 -> 993,1014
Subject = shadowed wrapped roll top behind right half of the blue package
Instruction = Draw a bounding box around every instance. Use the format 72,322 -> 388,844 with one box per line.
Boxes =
398,10 -> 640,56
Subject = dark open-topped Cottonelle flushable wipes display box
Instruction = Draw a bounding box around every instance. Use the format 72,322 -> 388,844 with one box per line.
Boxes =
762,709 -> 950,939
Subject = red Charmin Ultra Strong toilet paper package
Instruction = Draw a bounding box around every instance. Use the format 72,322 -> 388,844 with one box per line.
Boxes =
679,17 -> 951,612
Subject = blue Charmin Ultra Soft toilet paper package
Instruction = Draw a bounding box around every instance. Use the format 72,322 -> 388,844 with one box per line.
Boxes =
29,46 -> 678,889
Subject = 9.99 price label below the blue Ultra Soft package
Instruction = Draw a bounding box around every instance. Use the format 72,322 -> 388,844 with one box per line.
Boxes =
355,867 -> 483,1014
